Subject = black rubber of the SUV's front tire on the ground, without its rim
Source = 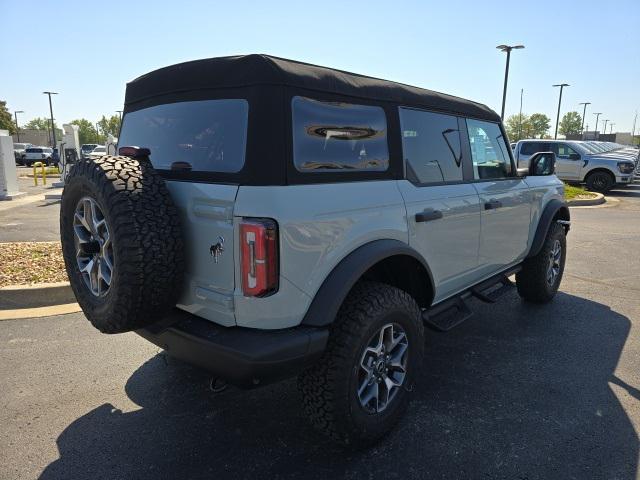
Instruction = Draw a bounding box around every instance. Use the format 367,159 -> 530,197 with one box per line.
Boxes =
516,222 -> 567,303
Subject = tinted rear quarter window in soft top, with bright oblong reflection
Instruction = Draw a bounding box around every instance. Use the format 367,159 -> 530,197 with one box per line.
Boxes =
292,97 -> 389,172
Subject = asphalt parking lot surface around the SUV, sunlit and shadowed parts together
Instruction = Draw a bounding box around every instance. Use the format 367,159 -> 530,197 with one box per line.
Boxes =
0,184 -> 640,479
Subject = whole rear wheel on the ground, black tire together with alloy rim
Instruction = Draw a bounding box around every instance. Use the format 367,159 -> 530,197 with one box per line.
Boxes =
298,282 -> 424,447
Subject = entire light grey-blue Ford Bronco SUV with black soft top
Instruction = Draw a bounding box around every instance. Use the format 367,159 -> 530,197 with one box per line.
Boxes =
60,55 -> 570,445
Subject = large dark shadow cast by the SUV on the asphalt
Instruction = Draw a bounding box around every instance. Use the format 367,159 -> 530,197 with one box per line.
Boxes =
41,294 -> 639,479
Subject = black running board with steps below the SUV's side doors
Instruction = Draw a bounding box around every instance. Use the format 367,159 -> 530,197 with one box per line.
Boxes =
422,265 -> 522,332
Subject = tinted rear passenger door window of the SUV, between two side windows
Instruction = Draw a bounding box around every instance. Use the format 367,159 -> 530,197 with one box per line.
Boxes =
400,108 -> 462,183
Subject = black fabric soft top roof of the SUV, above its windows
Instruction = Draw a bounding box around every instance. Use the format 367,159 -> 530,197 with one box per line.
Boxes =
125,54 -> 500,121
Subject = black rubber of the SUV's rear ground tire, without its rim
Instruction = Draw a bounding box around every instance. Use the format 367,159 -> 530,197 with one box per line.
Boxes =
298,282 -> 424,448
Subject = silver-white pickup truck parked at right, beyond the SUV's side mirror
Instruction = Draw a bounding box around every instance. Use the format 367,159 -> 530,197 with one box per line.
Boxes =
515,139 -> 637,193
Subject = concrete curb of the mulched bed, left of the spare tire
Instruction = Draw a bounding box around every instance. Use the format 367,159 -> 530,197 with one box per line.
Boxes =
0,282 -> 76,314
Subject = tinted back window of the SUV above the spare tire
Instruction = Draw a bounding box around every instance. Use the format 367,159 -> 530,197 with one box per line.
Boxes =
118,99 -> 249,173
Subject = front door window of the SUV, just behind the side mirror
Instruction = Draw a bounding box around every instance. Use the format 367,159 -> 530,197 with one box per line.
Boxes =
467,118 -> 512,180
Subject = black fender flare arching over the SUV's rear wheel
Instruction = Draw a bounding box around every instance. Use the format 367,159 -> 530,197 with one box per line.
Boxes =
302,239 -> 434,327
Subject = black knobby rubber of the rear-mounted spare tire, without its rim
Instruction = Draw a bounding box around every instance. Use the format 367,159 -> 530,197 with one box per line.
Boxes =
60,156 -> 184,333
